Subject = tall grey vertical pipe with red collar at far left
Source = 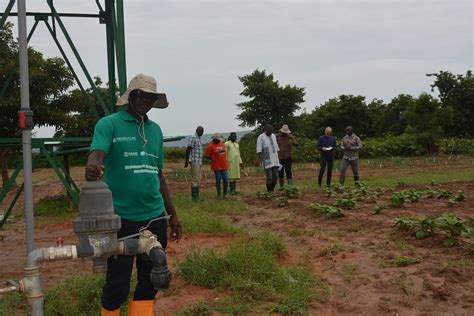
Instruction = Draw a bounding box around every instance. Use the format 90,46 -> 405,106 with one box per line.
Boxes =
17,0 -> 35,253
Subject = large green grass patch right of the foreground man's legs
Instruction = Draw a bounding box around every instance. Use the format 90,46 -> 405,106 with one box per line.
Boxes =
177,233 -> 325,314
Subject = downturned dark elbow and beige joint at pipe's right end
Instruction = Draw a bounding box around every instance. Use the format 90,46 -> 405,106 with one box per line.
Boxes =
138,230 -> 171,290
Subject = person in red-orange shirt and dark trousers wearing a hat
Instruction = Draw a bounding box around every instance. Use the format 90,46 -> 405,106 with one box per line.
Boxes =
206,133 -> 228,199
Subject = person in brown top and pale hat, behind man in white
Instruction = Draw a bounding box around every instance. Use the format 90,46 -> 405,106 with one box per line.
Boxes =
276,124 -> 298,190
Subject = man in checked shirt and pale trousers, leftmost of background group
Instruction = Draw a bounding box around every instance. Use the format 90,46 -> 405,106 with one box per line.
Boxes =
184,126 -> 204,202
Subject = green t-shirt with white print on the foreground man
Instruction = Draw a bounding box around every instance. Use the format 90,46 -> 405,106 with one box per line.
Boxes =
90,109 -> 164,221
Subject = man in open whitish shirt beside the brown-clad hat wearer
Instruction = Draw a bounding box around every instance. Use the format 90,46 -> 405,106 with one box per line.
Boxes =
255,124 -> 280,192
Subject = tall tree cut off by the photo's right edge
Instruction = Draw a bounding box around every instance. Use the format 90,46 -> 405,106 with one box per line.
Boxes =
428,71 -> 474,136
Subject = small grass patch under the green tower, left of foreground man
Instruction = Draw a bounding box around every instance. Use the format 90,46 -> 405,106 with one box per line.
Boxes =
34,194 -> 79,219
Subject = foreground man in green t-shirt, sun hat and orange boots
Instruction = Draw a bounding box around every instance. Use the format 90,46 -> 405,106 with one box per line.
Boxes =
85,74 -> 182,316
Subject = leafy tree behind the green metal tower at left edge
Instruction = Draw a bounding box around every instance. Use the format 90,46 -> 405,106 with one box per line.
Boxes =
0,23 -> 74,185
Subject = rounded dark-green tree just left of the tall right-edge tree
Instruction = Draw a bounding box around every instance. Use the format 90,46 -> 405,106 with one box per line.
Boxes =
404,93 -> 452,154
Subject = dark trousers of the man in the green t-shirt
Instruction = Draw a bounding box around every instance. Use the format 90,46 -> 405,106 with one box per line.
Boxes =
101,219 -> 168,311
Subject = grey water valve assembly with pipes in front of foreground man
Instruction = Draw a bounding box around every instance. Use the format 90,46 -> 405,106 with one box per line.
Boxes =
0,181 -> 171,316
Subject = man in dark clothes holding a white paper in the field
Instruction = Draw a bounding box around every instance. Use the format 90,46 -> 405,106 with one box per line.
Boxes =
316,126 -> 336,188
